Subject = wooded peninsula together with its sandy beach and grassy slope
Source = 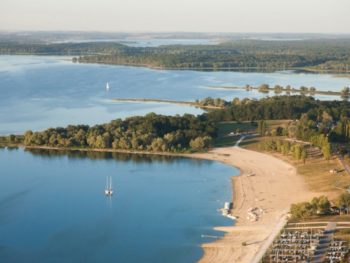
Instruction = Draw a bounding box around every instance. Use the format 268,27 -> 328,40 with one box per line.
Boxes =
0,96 -> 350,263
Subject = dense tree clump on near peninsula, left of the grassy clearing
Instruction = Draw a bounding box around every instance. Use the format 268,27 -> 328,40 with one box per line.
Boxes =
23,113 -> 216,152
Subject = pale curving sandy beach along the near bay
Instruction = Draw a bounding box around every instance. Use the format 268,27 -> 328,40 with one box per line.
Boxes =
192,147 -> 318,263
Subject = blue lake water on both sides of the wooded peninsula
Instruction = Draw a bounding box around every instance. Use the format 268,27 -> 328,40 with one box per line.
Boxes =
0,56 -> 349,263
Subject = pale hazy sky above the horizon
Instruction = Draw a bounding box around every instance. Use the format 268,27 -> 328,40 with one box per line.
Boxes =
0,0 -> 350,33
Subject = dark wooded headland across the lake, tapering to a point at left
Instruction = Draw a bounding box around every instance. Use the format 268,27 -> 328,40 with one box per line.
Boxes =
75,40 -> 350,71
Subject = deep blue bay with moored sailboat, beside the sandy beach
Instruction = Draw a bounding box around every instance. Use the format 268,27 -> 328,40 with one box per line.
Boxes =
0,149 -> 237,263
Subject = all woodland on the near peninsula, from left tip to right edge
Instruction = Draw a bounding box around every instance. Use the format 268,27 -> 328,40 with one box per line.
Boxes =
0,95 -> 350,154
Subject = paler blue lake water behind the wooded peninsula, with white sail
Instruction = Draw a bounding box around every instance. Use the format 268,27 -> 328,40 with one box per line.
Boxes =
0,56 -> 350,134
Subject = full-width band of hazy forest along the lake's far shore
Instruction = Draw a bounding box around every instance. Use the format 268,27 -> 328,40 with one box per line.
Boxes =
0,39 -> 350,72
